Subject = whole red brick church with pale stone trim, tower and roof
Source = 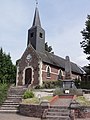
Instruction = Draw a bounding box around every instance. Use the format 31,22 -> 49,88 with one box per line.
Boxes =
16,7 -> 84,86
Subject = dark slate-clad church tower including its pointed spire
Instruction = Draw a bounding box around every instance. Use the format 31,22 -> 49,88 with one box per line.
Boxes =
27,7 -> 45,52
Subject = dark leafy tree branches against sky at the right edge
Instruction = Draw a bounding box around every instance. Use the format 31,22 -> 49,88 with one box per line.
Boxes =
80,15 -> 90,60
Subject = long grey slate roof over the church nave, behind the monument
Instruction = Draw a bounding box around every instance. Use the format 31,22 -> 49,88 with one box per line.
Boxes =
38,52 -> 84,74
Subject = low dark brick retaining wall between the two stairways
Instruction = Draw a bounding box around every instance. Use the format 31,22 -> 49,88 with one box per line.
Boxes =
19,104 -> 49,118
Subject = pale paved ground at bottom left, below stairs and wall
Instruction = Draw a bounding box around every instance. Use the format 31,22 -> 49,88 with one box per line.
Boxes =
0,113 -> 41,120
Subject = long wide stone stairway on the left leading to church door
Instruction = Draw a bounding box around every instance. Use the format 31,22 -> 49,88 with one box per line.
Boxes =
0,86 -> 27,113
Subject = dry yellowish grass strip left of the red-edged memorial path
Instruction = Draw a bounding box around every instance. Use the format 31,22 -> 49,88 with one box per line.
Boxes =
22,96 -> 53,104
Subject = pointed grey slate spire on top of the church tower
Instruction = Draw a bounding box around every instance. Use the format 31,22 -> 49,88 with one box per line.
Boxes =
32,6 -> 41,27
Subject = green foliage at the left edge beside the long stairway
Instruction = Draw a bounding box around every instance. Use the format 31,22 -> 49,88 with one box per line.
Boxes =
0,84 -> 9,104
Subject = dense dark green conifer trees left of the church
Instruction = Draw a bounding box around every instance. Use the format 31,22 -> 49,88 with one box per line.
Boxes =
0,48 -> 16,83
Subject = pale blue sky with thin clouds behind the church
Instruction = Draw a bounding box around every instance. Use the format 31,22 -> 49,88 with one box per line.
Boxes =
0,0 -> 90,66
